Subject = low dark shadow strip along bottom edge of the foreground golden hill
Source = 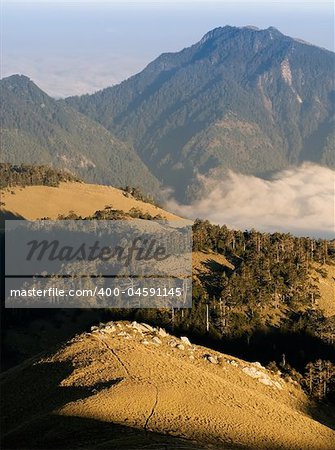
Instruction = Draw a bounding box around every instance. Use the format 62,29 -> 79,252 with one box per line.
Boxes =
2,414 -> 213,450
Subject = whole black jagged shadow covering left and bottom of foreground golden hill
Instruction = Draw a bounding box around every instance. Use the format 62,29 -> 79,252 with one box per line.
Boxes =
1,361 -> 210,450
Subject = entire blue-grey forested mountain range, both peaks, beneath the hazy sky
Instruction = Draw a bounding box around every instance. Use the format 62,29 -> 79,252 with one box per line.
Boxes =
0,26 -> 335,201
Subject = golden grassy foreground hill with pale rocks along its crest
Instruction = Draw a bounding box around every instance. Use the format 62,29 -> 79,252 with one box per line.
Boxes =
1,321 -> 335,450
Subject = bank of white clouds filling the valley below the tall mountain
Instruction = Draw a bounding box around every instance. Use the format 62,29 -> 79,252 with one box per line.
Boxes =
166,163 -> 335,239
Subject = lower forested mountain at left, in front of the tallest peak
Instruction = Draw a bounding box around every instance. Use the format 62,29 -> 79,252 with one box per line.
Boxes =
0,75 -> 159,193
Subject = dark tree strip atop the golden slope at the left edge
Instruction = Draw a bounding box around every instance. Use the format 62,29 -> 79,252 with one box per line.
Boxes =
0,163 -> 80,188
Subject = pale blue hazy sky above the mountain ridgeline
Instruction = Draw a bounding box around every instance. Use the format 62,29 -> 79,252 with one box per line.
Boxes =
1,0 -> 334,96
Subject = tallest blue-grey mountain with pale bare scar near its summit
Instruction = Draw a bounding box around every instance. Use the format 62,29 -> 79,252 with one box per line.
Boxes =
66,26 -> 335,197
